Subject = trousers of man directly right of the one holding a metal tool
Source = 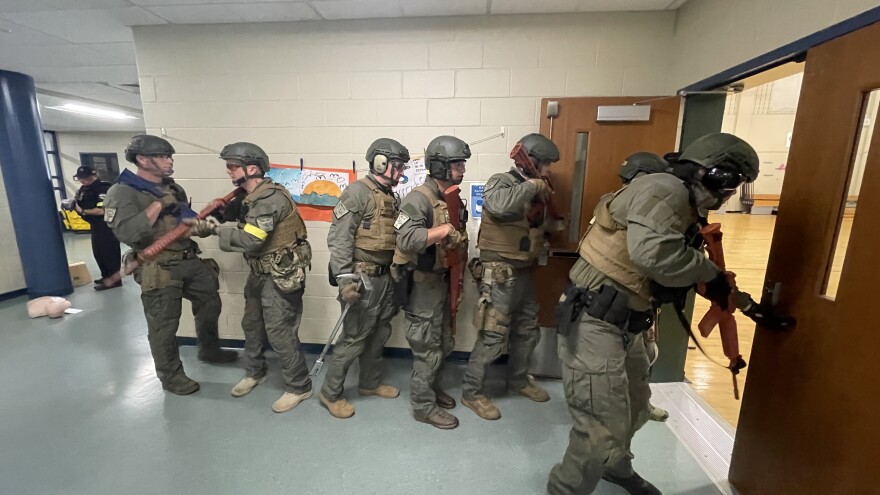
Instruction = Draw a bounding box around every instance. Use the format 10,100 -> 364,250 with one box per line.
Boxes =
404,271 -> 455,418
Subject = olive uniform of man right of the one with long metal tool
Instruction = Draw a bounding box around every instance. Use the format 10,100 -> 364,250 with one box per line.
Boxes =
394,177 -> 467,419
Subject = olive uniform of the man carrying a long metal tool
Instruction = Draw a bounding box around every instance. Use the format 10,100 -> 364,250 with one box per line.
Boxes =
321,175 -> 399,402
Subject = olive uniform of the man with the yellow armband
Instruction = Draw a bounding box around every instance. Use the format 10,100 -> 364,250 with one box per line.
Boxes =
219,178 -> 312,394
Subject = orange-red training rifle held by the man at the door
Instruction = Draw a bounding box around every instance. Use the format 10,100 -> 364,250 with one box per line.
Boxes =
697,223 -> 746,400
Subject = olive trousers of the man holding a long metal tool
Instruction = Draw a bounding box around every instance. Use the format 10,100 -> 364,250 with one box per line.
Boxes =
321,273 -> 397,402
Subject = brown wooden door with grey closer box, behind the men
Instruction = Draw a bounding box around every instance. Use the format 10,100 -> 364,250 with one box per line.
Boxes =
534,96 -> 681,327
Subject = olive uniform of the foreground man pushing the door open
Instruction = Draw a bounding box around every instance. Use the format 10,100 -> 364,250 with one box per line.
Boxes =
547,173 -> 718,495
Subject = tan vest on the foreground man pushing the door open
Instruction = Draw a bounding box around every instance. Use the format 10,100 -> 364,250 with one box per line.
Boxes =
578,187 -> 651,299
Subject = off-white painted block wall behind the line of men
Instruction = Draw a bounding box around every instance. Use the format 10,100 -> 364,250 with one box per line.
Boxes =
133,12 -> 675,344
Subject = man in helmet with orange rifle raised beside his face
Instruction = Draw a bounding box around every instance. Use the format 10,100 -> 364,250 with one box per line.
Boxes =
461,134 -> 559,420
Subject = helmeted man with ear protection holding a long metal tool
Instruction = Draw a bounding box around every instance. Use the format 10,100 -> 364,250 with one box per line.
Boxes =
319,138 -> 409,418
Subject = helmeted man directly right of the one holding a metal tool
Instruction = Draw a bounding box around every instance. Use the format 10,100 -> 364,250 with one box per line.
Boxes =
394,136 -> 471,429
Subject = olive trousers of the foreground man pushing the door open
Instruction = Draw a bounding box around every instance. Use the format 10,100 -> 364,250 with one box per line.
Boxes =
547,315 -> 651,495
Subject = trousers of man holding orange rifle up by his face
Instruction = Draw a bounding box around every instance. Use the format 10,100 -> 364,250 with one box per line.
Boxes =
461,269 -> 540,400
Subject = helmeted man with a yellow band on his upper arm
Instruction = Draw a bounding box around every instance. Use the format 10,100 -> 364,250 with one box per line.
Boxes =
190,143 -> 312,413
